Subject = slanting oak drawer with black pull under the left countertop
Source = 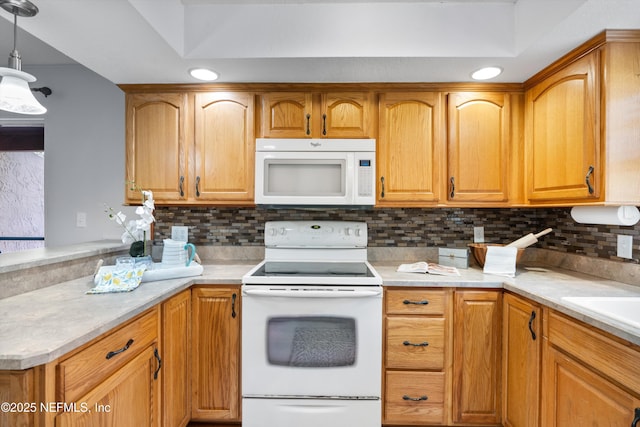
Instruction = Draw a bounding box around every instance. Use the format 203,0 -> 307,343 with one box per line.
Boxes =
57,310 -> 158,402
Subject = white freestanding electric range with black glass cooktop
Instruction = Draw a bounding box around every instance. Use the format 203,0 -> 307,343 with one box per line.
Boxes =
242,221 -> 382,427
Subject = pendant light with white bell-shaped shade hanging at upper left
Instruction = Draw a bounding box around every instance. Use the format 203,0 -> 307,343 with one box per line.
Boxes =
0,0 -> 47,114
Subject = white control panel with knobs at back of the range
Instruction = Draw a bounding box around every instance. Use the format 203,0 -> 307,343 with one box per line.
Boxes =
264,221 -> 367,248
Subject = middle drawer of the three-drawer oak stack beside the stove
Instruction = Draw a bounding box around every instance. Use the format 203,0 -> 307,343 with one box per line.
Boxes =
385,317 -> 445,370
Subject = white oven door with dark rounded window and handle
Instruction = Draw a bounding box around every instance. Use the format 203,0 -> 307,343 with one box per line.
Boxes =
242,285 -> 382,399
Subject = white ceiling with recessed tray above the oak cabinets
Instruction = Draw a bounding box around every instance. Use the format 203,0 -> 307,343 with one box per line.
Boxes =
0,0 -> 640,84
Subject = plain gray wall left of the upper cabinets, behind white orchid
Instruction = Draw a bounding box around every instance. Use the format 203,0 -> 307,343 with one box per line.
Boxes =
0,65 -> 133,247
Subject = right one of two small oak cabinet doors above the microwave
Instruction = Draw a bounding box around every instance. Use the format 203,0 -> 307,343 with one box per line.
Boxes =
320,92 -> 372,138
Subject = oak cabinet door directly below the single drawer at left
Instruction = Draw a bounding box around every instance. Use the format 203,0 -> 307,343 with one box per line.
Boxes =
56,345 -> 160,427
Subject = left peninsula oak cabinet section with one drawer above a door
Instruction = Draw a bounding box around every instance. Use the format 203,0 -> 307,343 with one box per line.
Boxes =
53,307 -> 162,427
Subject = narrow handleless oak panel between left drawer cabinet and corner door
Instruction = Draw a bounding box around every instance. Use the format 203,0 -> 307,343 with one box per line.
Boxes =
161,290 -> 191,427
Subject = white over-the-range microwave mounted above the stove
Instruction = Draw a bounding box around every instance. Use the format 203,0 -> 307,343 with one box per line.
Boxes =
255,138 -> 376,207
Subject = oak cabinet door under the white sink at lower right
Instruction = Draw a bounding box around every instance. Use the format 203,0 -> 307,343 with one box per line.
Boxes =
542,345 -> 640,427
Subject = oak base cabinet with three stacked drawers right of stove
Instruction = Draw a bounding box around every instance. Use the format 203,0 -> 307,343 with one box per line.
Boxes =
383,288 -> 452,425
